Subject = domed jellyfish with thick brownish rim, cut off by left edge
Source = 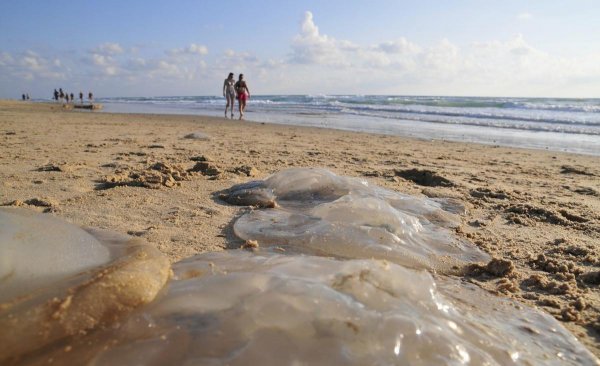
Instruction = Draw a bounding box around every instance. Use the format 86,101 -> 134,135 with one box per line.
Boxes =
0,208 -> 170,363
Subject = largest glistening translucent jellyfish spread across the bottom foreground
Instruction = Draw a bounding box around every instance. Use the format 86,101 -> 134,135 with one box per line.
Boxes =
23,251 -> 598,365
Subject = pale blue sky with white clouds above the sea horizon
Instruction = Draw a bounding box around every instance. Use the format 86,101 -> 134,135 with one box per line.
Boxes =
0,0 -> 600,98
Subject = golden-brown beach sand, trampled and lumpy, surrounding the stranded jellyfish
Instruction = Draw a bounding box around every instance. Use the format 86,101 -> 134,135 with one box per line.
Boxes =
0,101 -> 600,356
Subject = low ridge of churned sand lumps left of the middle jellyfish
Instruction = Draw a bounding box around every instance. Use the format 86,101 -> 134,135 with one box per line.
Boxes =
97,162 -> 191,189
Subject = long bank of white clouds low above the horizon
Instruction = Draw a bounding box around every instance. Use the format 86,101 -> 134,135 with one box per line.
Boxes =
0,12 -> 600,96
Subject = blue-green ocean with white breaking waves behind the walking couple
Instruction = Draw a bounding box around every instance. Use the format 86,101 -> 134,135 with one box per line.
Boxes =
98,95 -> 600,155
